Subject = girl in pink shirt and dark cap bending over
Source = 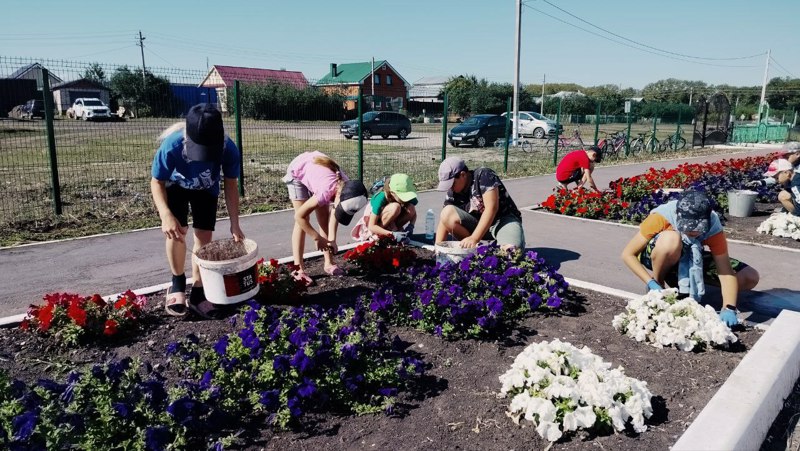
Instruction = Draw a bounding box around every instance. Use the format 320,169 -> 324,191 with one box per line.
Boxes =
283,151 -> 367,284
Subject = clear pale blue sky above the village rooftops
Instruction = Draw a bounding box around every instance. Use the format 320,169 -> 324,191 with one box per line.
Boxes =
0,0 -> 800,89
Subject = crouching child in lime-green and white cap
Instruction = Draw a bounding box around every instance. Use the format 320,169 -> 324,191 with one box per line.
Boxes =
352,173 -> 417,241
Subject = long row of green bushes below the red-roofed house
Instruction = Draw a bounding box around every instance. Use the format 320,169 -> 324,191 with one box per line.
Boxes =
227,83 -> 344,121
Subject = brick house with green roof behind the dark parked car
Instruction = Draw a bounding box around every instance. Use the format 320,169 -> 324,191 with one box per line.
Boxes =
316,60 -> 409,111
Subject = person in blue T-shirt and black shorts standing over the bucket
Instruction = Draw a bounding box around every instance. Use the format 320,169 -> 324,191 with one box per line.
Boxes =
150,103 -> 244,316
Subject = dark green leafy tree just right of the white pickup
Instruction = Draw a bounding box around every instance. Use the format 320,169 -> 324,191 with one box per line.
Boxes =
110,66 -> 174,117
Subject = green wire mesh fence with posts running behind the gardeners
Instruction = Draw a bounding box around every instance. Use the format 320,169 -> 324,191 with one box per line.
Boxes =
0,56 -> 732,243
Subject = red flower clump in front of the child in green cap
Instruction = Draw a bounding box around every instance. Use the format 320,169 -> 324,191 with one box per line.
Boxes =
344,236 -> 417,274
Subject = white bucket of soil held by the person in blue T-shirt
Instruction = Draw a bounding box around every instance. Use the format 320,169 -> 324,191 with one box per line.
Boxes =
192,238 -> 259,304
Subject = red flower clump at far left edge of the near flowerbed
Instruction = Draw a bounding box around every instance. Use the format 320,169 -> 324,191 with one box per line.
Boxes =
19,290 -> 147,344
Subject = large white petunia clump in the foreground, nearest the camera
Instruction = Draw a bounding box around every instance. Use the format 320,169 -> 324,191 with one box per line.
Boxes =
500,340 -> 653,442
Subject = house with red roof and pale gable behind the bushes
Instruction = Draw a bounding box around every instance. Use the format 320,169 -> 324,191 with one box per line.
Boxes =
200,64 -> 308,112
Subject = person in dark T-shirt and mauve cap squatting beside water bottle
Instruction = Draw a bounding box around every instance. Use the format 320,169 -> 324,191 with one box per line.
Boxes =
435,157 -> 525,250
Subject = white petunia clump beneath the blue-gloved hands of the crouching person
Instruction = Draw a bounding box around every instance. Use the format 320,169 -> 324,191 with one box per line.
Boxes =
612,289 -> 737,351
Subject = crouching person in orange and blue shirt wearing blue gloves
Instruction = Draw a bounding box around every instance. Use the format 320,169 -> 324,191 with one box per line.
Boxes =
622,191 -> 759,326
